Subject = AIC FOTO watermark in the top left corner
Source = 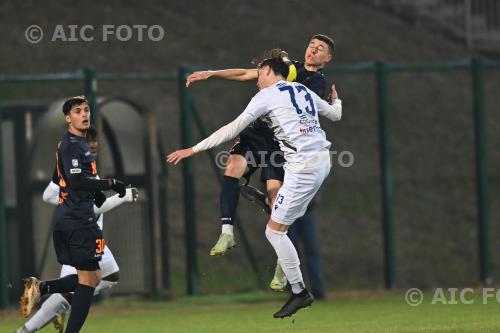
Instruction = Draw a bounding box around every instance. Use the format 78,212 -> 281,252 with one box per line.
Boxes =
24,24 -> 165,44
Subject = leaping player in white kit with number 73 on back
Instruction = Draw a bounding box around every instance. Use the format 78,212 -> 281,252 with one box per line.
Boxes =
167,50 -> 342,318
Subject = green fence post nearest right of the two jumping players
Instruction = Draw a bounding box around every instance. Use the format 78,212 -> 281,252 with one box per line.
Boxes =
375,62 -> 396,289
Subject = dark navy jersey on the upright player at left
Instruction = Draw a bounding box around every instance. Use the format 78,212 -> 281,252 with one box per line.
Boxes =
54,132 -> 97,230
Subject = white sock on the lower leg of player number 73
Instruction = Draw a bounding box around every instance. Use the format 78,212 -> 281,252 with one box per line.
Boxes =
266,227 -> 304,286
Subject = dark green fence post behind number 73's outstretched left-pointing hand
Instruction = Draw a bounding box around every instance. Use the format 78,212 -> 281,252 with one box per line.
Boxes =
178,67 -> 198,295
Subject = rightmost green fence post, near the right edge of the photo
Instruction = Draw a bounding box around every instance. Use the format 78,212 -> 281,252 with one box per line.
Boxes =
471,59 -> 492,284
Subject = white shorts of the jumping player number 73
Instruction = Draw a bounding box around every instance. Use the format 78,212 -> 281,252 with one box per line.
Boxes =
271,165 -> 330,225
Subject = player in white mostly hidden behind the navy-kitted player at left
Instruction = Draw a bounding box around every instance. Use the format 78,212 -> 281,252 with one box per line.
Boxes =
15,126 -> 139,333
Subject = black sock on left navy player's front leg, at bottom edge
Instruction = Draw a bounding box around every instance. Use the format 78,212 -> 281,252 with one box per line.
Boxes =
65,284 -> 95,333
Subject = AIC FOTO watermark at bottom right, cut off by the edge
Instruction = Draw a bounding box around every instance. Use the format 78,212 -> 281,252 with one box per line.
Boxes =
405,288 -> 500,306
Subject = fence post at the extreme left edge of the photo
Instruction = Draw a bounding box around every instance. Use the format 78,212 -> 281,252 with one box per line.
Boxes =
0,105 -> 9,309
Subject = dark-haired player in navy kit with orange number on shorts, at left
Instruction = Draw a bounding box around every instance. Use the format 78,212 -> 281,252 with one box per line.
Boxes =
19,96 -> 126,333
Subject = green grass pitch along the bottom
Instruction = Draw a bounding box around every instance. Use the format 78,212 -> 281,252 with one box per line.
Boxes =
0,292 -> 500,333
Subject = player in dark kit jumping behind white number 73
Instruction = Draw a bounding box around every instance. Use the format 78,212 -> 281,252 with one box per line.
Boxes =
186,34 -> 337,299
